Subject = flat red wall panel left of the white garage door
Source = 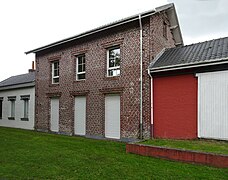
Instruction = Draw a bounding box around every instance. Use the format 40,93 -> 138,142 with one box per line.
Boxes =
153,74 -> 197,139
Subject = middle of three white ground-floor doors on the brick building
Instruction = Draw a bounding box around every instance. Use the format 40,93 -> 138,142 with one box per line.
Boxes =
74,96 -> 86,135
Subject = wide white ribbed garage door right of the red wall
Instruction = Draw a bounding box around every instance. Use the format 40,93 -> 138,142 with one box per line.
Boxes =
197,71 -> 228,139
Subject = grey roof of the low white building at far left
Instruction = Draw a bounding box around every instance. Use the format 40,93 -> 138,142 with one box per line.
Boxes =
0,72 -> 35,88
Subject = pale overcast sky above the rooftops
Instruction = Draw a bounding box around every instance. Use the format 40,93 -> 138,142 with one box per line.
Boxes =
0,0 -> 228,81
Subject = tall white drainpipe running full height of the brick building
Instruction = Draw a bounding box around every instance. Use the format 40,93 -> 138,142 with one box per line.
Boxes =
139,14 -> 143,139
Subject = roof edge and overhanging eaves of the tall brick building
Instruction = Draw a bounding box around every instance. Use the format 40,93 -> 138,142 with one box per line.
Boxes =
25,3 -> 183,54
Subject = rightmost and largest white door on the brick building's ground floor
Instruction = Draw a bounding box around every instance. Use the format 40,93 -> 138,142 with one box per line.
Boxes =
105,94 -> 120,139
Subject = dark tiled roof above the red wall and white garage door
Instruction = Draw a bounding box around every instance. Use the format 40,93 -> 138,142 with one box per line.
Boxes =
149,37 -> 228,72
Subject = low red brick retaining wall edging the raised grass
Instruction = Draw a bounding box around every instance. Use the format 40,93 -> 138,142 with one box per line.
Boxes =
126,144 -> 228,168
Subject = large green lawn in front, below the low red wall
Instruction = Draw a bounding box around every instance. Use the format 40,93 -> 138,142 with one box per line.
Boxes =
0,127 -> 228,179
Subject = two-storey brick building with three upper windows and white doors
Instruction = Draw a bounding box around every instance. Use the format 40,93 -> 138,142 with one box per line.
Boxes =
26,4 -> 183,139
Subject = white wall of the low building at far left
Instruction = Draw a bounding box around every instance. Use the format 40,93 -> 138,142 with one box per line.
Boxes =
0,87 -> 35,129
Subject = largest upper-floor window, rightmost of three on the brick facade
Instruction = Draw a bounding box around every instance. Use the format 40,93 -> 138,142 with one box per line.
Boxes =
107,47 -> 120,77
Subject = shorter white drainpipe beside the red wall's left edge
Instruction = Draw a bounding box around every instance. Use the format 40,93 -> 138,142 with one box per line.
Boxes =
148,68 -> 154,138
